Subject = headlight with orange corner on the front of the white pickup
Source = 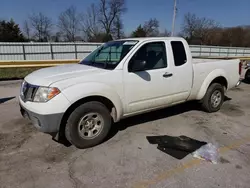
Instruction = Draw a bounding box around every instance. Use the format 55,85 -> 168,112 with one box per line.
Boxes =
33,87 -> 60,102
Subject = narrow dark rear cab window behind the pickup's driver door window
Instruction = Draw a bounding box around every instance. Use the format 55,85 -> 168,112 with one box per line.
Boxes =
171,41 -> 187,67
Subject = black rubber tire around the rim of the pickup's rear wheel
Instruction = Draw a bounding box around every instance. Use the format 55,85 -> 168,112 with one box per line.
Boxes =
201,83 -> 225,113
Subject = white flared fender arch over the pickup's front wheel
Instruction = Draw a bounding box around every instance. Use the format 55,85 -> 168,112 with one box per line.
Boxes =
62,82 -> 123,120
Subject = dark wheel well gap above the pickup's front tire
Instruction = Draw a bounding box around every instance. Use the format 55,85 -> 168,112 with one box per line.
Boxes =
59,96 -> 117,135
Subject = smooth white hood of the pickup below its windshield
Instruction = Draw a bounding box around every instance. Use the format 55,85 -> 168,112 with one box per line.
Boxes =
25,64 -> 108,86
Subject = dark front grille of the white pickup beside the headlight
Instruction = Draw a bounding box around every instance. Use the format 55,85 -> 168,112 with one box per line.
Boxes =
21,82 -> 38,101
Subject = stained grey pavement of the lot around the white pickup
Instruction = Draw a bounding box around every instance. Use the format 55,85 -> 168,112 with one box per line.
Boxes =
0,82 -> 250,188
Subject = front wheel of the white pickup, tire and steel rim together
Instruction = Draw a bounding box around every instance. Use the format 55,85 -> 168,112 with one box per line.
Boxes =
65,102 -> 112,149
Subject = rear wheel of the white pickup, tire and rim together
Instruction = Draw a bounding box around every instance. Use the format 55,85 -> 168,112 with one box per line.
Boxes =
202,83 -> 225,113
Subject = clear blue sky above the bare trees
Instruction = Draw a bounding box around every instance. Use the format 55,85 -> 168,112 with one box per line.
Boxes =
0,0 -> 250,33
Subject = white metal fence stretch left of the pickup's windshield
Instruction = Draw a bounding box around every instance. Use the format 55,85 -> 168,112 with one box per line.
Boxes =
0,42 -> 102,60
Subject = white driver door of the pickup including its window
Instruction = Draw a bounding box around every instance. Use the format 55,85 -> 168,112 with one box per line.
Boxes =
124,41 -> 173,115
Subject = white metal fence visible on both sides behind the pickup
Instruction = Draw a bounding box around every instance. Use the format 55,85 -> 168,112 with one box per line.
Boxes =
0,42 -> 250,60
